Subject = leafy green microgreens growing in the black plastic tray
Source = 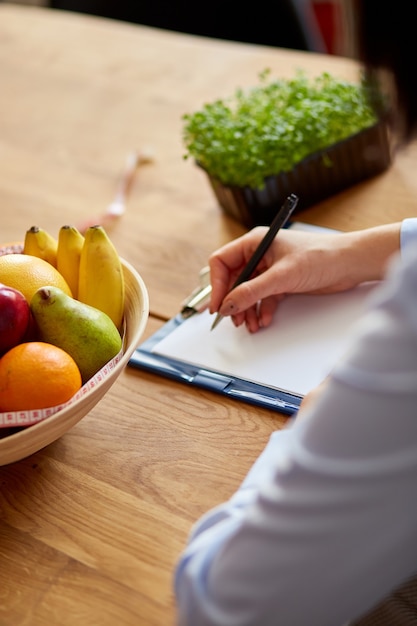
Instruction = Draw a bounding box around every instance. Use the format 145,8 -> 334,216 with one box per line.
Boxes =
183,70 -> 377,188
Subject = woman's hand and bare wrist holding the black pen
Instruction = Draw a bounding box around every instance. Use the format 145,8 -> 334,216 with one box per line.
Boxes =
209,223 -> 400,332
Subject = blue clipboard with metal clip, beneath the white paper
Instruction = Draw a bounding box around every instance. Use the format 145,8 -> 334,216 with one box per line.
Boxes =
128,313 -> 302,415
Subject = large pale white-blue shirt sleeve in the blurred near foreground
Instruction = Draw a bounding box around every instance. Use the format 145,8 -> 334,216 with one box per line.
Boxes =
175,247 -> 417,626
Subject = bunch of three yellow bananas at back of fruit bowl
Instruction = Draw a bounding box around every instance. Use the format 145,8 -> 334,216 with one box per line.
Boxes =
23,225 -> 125,331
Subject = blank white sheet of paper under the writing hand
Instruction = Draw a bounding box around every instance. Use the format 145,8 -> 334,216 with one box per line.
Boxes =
153,284 -> 375,396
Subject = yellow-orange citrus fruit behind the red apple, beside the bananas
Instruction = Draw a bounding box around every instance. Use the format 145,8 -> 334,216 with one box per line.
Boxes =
0,254 -> 72,304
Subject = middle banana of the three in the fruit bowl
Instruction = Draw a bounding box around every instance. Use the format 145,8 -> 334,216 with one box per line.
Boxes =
56,225 -> 84,298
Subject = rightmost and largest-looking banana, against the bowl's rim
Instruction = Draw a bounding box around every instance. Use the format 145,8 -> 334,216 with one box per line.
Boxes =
78,226 -> 125,330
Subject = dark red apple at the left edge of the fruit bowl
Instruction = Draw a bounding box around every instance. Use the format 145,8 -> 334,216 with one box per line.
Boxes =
0,283 -> 30,354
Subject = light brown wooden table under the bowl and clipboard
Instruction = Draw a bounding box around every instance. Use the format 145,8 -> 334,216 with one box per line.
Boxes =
0,4 -> 416,626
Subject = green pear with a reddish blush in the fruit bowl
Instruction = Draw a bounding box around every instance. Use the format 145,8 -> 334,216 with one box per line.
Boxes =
30,286 -> 122,383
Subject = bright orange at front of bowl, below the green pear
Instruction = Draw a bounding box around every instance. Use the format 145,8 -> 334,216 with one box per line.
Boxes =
0,341 -> 81,412
